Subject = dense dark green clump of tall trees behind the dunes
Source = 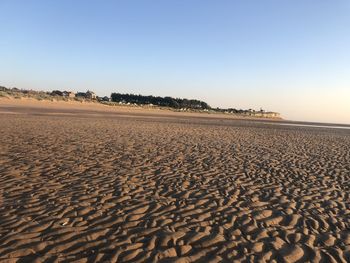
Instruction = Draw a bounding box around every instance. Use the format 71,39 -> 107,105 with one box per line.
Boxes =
111,93 -> 211,110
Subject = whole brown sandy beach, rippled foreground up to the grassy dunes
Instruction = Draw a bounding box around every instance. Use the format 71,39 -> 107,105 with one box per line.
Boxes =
0,100 -> 350,262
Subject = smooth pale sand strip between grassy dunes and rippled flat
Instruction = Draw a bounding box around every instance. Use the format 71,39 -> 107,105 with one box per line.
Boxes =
0,97 -> 350,129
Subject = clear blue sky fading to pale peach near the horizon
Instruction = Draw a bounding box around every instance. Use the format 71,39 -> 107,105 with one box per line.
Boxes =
0,0 -> 350,124
